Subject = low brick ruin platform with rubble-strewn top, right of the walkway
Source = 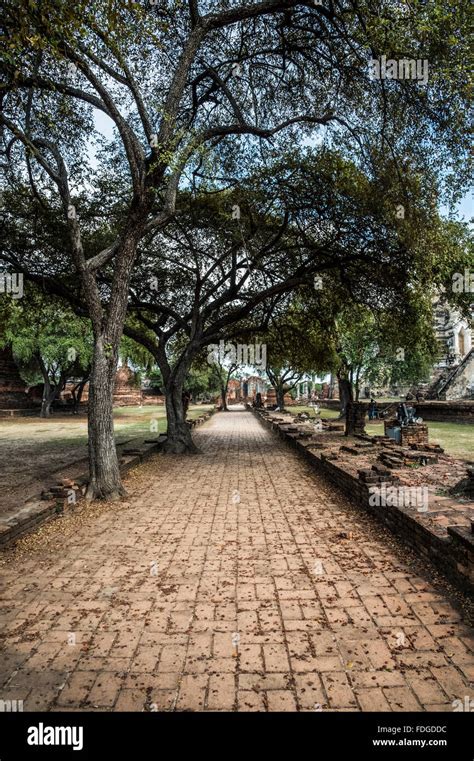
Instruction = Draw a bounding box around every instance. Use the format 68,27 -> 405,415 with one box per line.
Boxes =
254,410 -> 474,593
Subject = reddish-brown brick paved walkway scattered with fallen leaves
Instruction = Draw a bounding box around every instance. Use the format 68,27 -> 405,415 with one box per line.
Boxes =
0,411 -> 474,711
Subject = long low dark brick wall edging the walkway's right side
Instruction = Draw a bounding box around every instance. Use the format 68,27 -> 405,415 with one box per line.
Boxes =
253,410 -> 474,593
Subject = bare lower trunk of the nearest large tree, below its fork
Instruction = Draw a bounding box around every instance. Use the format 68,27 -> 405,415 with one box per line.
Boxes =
86,338 -> 126,500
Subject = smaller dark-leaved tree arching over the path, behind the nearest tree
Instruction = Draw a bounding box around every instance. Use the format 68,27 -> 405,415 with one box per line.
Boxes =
121,148 -> 462,452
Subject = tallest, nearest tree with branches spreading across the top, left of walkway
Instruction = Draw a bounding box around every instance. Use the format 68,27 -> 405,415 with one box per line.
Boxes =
0,0 -> 472,486
